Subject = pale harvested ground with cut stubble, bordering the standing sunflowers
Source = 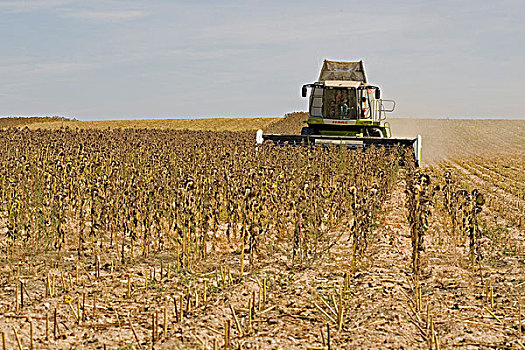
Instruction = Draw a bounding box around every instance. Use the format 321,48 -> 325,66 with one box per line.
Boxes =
0,116 -> 525,349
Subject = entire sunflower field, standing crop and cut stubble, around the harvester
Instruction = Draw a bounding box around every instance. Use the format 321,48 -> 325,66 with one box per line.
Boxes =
0,117 -> 525,350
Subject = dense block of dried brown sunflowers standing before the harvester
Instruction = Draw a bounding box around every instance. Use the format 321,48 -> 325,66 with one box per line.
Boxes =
0,129 -> 410,269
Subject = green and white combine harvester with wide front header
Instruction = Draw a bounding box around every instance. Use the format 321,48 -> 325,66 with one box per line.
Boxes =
256,60 -> 421,165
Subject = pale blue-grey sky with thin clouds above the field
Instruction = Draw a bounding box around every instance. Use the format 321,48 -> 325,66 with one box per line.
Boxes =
0,0 -> 525,120
